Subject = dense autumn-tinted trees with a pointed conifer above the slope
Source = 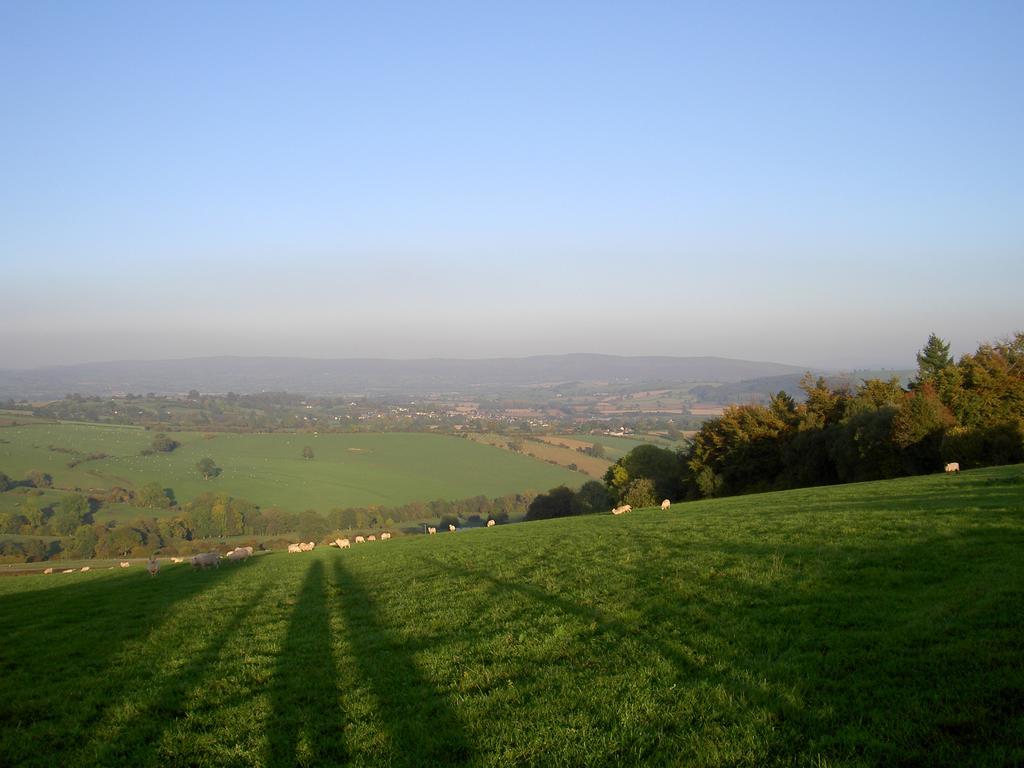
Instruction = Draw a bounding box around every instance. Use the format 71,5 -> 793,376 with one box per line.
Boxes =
683,334 -> 1024,498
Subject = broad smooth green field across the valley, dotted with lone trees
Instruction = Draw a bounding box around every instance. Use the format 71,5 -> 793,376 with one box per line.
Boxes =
0,424 -> 587,512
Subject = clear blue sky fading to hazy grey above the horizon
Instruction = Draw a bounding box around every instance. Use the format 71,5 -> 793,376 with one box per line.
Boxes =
0,2 -> 1024,368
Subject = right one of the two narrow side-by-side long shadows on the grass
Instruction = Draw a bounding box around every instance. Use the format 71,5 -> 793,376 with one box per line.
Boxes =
334,559 -> 472,766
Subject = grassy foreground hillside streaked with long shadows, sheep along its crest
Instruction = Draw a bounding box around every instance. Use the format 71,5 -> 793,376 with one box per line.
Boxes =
0,466 -> 1024,766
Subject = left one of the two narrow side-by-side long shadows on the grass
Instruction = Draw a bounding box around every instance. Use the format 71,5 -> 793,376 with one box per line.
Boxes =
267,560 -> 347,766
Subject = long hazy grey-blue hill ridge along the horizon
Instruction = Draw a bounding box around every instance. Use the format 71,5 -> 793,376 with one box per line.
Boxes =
0,354 -> 803,399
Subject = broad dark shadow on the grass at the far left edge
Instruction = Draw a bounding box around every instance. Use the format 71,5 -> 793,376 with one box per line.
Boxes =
0,565 -> 245,766
